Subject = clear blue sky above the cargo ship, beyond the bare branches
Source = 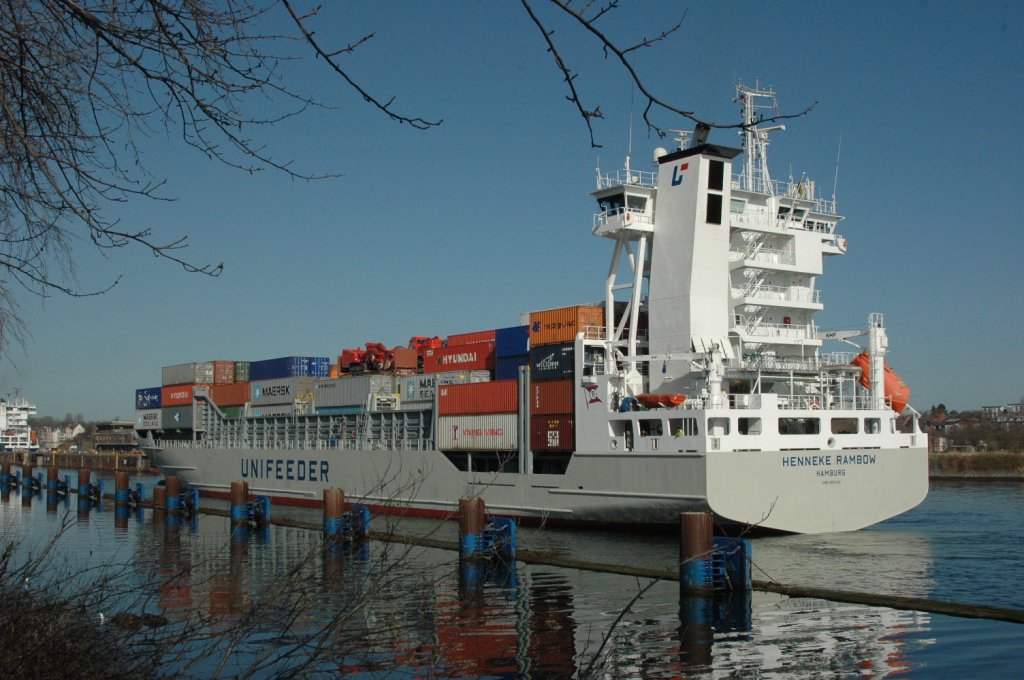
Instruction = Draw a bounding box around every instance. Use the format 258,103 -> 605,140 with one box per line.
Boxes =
0,0 -> 1024,419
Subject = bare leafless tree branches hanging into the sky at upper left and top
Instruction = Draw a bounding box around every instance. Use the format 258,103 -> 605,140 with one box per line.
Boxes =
0,0 -> 803,350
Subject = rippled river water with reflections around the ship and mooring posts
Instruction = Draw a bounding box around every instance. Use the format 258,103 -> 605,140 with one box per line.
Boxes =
0,478 -> 1024,678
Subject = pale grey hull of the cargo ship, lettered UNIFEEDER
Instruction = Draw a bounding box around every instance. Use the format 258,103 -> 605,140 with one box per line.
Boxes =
147,440 -> 928,534
